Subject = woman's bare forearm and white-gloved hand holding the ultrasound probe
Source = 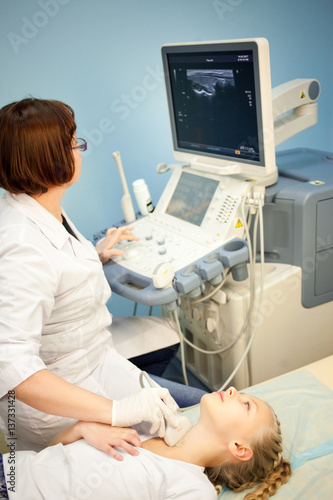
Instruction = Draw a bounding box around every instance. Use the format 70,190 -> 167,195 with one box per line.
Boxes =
15,369 -> 178,437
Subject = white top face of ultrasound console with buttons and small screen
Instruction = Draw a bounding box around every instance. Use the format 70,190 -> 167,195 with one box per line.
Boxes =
114,169 -> 247,277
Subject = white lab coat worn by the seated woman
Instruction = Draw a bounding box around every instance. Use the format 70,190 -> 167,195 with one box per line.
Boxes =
0,193 -> 139,451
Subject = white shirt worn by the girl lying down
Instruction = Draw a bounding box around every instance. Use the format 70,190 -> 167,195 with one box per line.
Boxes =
3,438 -> 217,500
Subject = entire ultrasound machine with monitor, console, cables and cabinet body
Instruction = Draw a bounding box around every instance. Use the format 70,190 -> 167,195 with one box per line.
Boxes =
95,38 -> 333,390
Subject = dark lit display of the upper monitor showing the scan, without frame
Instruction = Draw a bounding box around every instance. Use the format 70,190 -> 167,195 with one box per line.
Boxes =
169,54 -> 259,161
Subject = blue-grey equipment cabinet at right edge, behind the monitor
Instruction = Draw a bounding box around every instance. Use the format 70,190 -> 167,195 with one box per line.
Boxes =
264,149 -> 333,307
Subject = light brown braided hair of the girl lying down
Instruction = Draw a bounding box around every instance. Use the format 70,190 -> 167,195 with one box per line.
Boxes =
205,407 -> 291,500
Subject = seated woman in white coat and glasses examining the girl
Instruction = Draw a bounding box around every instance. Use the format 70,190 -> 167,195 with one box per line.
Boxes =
0,98 -> 182,454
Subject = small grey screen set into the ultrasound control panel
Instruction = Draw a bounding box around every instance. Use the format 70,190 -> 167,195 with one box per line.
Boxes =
166,173 -> 218,226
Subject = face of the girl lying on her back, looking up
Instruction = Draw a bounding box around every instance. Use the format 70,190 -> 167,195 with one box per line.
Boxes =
200,387 -> 273,443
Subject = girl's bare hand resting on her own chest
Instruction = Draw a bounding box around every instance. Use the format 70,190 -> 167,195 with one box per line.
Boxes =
49,421 -> 141,461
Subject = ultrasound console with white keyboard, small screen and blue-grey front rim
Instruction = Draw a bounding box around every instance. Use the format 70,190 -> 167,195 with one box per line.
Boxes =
100,166 -> 250,303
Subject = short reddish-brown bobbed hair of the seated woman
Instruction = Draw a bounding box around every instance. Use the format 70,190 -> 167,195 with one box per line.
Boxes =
0,98 -> 76,195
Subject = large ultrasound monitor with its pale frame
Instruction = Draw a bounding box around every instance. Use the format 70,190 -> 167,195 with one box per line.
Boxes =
162,38 -> 277,185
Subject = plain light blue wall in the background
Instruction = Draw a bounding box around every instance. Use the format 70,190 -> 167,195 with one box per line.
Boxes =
0,0 -> 333,314
